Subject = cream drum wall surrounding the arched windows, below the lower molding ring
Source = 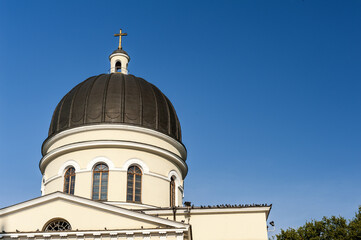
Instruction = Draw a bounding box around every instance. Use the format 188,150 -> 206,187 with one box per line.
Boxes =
43,148 -> 183,207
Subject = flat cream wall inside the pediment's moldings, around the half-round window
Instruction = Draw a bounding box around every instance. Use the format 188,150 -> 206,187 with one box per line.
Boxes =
0,200 -> 157,232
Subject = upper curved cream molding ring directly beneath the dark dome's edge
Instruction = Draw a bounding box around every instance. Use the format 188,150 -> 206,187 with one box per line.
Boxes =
42,124 -> 187,161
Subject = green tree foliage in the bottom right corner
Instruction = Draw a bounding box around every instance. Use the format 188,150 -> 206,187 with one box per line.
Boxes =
276,206 -> 361,240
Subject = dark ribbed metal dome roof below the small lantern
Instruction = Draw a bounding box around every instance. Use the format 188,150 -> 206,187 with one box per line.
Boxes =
49,73 -> 182,142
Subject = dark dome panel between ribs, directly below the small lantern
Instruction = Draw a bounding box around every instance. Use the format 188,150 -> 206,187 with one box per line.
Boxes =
104,74 -> 123,123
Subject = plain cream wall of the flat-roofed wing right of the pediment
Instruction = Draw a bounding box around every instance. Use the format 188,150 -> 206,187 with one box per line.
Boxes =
145,207 -> 270,240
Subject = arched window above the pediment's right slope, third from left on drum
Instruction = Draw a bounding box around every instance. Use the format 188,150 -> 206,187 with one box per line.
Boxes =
127,166 -> 142,202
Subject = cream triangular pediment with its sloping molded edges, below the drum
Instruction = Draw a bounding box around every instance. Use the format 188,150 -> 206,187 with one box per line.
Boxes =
0,192 -> 187,232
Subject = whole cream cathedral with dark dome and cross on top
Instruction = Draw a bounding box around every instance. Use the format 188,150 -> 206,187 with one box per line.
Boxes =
0,31 -> 271,240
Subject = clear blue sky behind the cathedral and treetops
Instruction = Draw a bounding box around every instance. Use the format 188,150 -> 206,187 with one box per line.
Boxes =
0,0 -> 361,236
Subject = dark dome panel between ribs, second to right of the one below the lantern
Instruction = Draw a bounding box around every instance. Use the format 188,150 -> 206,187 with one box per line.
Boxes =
139,79 -> 157,128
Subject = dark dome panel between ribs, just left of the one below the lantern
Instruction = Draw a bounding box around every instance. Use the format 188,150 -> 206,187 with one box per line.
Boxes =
85,75 -> 106,123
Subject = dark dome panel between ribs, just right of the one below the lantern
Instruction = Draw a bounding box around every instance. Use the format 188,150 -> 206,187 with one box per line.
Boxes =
124,75 -> 140,125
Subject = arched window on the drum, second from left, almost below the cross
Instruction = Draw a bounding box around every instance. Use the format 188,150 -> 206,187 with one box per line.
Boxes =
92,163 -> 109,201
